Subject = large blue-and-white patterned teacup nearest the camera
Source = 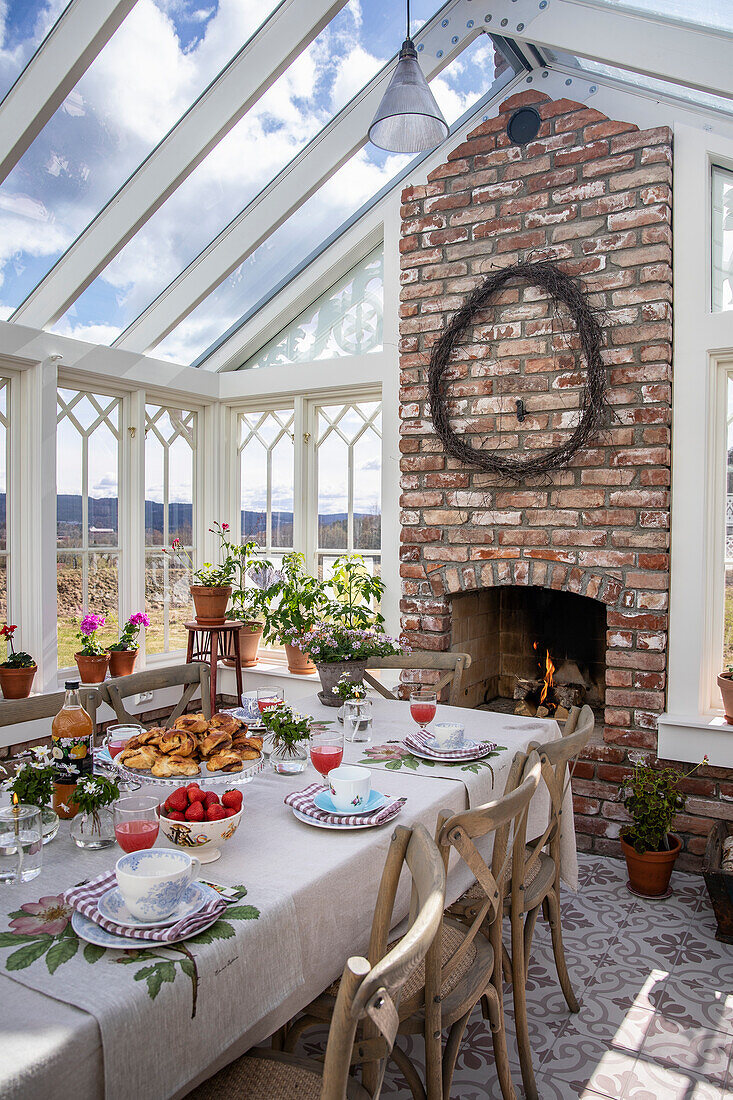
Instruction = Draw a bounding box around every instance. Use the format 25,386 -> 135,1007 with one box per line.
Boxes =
116,848 -> 201,921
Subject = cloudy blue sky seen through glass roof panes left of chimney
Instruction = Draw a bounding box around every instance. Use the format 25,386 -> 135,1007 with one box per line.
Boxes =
0,0 -> 501,362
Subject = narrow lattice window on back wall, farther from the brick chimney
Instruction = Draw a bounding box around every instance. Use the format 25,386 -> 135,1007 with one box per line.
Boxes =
239,408 -> 295,561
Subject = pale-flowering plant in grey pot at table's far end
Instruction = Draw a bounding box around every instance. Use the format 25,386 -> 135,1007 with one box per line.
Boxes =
298,623 -> 402,706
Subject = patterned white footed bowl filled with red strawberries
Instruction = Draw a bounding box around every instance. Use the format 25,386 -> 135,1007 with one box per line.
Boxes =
158,783 -> 243,864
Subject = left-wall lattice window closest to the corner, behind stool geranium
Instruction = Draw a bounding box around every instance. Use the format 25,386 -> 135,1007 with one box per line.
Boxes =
145,405 -> 197,655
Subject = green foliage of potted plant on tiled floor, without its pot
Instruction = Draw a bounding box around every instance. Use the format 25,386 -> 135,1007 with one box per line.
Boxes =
621,754 -> 708,855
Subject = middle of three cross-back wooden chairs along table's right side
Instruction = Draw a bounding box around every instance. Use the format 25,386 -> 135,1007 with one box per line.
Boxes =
286,754 -> 540,1100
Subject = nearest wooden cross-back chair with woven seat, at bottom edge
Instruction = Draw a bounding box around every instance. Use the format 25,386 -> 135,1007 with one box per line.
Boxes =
188,825 -> 446,1100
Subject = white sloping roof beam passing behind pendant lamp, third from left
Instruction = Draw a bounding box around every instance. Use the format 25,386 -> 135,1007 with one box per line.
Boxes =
112,0 -> 484,352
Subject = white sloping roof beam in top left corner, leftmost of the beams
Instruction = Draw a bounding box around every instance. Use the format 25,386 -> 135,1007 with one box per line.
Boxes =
0,0 -> 136,183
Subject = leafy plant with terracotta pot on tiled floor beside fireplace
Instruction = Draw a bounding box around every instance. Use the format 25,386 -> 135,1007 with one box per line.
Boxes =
621,752 -> 708,898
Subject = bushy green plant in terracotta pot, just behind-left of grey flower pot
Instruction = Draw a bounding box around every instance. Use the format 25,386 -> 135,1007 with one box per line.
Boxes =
269,552 -> 326,675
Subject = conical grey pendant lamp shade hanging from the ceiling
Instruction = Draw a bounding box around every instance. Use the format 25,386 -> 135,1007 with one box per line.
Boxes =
369,39 -> 448,153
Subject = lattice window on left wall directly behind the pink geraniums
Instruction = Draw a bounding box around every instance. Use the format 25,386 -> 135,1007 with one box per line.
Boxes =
56,387 -> 122,668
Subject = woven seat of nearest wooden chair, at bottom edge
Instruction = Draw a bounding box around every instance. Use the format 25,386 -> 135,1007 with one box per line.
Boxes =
186,1049 -> 369,1100
